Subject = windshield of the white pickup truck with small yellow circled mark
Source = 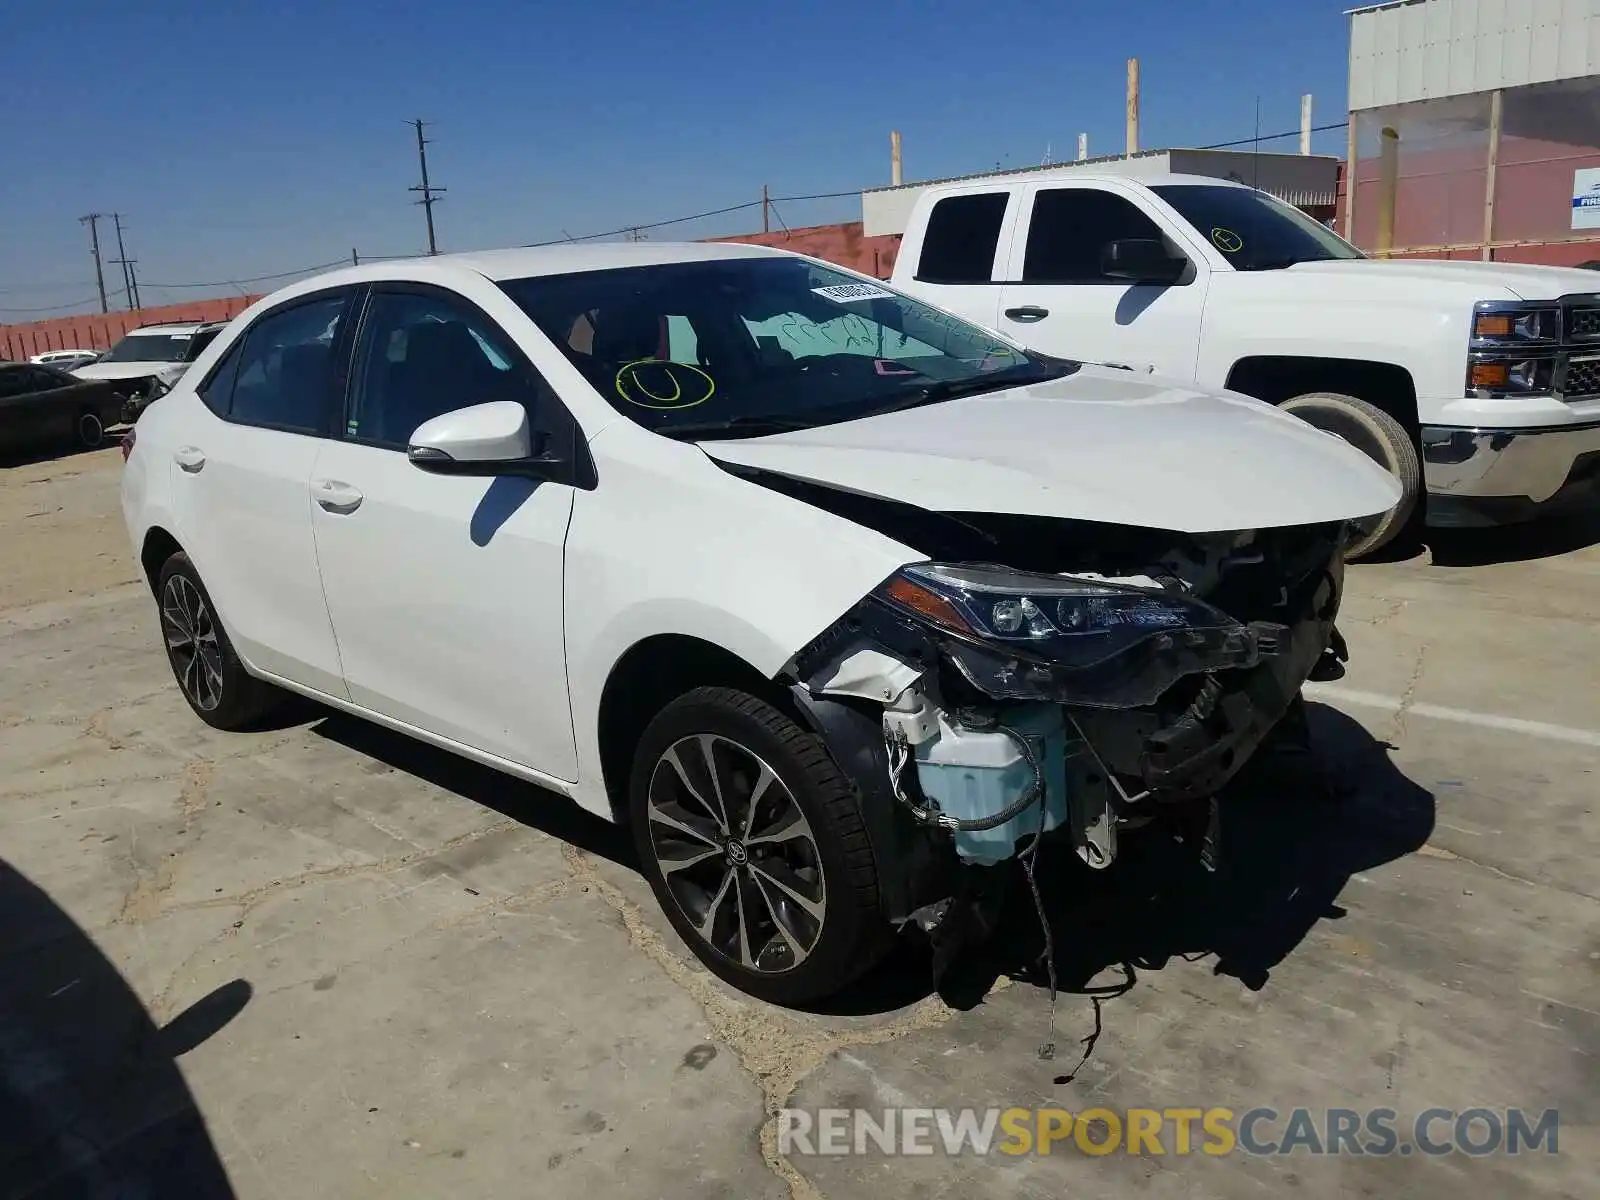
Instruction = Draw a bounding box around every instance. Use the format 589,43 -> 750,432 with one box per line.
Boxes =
1150,184 -> 1366,270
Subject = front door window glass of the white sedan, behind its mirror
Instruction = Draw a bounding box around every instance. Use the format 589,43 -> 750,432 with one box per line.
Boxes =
344,291 -> 549,450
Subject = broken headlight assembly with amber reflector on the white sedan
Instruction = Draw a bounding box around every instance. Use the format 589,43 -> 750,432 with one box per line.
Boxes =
874,563 -> 1285,709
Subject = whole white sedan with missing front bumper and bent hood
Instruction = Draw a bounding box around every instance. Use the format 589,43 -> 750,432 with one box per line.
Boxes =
123,245 -> 1400,1002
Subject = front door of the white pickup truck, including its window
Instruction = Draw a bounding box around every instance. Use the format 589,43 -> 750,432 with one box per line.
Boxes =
1000,184 -> 1210,379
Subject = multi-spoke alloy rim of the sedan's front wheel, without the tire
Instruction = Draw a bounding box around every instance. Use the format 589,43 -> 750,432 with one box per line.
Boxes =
646,733 -> 827,974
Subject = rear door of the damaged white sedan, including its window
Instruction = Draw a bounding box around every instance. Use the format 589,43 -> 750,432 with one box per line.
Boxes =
171,288 -> 355,699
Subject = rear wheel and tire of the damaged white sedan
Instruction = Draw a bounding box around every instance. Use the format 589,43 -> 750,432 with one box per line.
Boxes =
155,550 -> 282,731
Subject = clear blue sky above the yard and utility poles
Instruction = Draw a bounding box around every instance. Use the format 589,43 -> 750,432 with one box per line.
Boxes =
0,0 -> 1347,322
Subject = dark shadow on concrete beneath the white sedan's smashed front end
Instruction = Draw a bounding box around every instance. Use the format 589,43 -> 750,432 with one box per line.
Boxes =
829,704 -> 1434,1024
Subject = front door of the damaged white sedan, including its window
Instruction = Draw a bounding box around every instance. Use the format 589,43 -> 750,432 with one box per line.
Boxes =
310,285 -> 578,781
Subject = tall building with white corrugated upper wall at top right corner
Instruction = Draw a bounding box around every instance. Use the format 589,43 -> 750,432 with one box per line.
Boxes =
1342,0 -> 1600,264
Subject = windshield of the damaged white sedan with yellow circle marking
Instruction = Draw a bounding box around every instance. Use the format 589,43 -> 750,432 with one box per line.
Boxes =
501,258 -> 1077,438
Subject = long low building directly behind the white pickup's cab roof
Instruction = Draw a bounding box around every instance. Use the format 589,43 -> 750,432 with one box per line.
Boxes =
861,150 -> 1339,237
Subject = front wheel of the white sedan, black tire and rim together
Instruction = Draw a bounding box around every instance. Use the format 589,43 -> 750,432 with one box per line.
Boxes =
629,688 -> 890,1005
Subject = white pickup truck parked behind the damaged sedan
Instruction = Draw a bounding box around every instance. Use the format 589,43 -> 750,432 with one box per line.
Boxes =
893,168 -> 1600,557
